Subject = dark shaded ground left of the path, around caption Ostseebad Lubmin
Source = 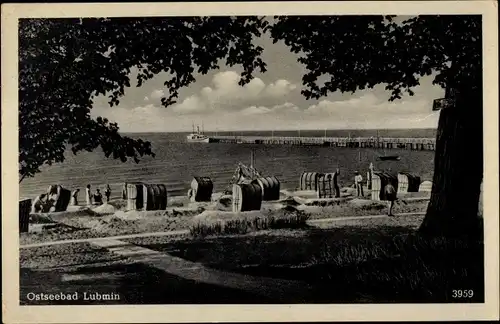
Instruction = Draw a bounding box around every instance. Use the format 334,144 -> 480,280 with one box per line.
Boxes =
20,264 -> 272,305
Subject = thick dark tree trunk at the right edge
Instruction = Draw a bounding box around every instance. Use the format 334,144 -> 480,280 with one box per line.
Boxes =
419,87 -> 483,239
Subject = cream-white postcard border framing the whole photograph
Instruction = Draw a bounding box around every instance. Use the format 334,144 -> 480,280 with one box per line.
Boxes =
1,1 -> 499,323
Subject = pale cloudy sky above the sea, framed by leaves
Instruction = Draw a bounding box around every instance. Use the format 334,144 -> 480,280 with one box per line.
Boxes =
91,20 -> 444,132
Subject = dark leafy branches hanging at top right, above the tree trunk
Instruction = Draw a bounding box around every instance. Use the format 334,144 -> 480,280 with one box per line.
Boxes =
268,15 -> 482,100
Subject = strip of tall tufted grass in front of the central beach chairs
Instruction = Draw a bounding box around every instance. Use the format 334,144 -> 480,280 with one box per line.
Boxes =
189,210 -> 310,237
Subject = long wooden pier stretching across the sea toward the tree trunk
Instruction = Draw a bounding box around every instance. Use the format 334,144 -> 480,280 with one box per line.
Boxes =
210,136 -> 436,151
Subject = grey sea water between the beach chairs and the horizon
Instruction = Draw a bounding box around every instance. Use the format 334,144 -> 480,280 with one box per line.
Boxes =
20,129 -> 435,197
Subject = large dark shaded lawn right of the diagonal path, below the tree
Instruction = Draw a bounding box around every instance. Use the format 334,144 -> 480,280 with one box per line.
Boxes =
151,217 -> 484,303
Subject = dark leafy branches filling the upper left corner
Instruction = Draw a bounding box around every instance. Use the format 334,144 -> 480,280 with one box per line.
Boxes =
19,17 -> 267,180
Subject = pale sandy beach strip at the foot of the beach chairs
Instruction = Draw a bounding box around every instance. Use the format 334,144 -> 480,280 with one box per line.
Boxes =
20,187 -> 429,245
